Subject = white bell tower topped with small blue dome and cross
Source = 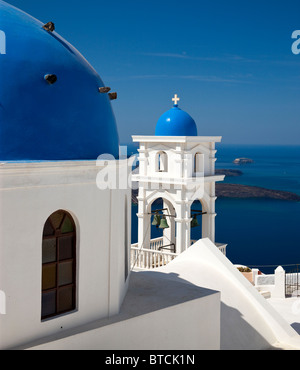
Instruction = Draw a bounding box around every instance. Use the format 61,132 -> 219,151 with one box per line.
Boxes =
132,95 -> 224,254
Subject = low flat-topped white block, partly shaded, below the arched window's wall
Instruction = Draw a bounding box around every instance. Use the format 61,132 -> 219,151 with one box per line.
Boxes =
20,272 -> 220,351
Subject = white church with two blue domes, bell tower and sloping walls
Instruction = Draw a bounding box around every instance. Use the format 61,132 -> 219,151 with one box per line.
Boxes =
0,0 -> 300,350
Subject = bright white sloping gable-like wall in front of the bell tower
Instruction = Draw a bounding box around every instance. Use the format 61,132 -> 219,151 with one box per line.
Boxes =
159,239 -> 300,350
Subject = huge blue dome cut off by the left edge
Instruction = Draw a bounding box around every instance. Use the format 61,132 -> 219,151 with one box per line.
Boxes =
0,0 -> 119,161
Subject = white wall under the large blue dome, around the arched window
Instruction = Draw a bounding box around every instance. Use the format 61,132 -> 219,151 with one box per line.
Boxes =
0,161 -> 131,349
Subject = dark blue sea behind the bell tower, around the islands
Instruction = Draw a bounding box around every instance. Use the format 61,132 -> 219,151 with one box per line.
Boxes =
131,144 -> 300,273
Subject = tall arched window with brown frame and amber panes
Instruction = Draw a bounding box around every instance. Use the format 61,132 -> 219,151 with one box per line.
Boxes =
42,210 -> 76,319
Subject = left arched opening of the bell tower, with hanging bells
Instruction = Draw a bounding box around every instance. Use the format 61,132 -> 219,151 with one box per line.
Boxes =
149,198 -> 176,253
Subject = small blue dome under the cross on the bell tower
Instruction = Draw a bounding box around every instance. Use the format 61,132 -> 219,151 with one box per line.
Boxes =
155,105 -> 198,136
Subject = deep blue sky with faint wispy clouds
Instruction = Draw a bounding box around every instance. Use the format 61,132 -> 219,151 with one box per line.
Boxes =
7,0 -> 300,145
